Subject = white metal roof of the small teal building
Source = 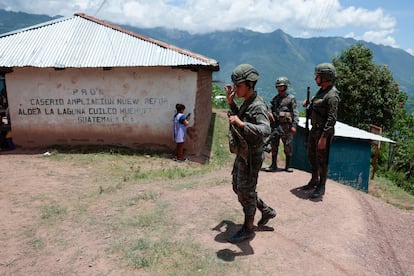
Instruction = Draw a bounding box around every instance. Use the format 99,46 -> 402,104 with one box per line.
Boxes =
299,117 -> 395,143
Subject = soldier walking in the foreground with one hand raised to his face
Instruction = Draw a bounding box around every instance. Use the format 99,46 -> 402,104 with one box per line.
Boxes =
225,64 -> 276,243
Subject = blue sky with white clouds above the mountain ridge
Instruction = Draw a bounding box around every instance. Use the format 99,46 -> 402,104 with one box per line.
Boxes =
0,0 -> 414,55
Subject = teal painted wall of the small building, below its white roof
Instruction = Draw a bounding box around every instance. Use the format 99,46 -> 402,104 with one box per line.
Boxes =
292,127 -> 371,192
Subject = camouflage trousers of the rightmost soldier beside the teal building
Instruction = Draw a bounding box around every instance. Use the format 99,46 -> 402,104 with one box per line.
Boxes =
307,128 -> 332,185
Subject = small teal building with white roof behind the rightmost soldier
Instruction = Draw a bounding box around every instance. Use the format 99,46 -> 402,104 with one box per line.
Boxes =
292,117 -> 395,192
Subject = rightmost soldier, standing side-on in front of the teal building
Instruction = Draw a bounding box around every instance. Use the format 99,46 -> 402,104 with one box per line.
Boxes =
302,63 -> 340,198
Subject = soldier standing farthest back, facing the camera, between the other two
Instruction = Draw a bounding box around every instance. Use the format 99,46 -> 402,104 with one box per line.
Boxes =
264,77 -> 299,172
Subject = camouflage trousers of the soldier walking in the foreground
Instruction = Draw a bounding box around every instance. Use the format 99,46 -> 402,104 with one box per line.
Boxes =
232,152 -> 268,216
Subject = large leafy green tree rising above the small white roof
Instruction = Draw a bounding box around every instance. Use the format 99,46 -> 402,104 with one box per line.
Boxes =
333,43 -> 407,133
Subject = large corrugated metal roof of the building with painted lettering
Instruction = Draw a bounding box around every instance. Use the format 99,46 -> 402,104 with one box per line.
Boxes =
0,14 -> 219,71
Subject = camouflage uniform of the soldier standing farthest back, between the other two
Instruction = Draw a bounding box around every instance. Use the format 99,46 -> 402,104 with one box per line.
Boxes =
270,93 -> 299,169
